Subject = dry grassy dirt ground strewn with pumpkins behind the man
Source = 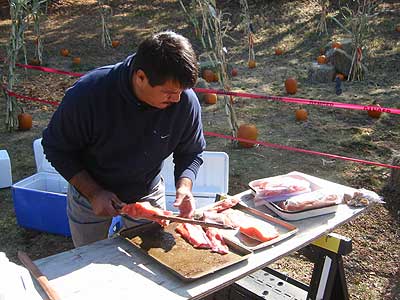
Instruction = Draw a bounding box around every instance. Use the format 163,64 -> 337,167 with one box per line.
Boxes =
0,0 -> 400,300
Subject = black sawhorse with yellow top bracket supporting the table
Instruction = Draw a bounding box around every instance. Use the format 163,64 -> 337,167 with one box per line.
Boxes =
211,233 -> 352,300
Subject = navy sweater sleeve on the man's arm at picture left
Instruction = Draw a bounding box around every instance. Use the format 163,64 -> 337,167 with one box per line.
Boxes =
42,83 -> 92,181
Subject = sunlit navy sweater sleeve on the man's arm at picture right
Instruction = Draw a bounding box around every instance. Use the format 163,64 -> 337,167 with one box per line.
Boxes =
174,90 -> 206,183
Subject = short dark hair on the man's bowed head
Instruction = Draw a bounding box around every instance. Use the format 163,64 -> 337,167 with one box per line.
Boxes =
133,31 -> 198,89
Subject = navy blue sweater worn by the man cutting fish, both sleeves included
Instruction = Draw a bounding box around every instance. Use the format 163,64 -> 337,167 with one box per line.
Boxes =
42,55 -> 205,203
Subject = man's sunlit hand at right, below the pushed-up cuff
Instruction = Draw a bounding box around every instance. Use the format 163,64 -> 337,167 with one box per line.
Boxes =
174,178 -> 196,218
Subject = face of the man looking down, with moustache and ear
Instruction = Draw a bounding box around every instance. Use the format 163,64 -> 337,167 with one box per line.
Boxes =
132,70 -> 183,109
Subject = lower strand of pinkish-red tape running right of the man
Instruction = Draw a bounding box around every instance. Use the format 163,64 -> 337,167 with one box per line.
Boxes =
204,131 -> 400,169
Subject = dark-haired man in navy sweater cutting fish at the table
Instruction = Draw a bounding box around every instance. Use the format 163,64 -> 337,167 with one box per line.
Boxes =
42,31 -> 205,247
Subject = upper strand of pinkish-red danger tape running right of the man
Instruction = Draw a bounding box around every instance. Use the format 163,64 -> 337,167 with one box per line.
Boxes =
193,88 -> 400,114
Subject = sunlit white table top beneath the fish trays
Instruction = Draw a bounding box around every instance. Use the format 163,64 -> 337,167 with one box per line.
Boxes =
35,173 -> 364,300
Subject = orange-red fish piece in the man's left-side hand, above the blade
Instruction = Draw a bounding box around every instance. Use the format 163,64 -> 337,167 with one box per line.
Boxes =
121,201 -> 173,227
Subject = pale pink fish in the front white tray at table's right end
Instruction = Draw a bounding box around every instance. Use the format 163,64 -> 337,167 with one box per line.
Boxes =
277,189 -> 343,211
